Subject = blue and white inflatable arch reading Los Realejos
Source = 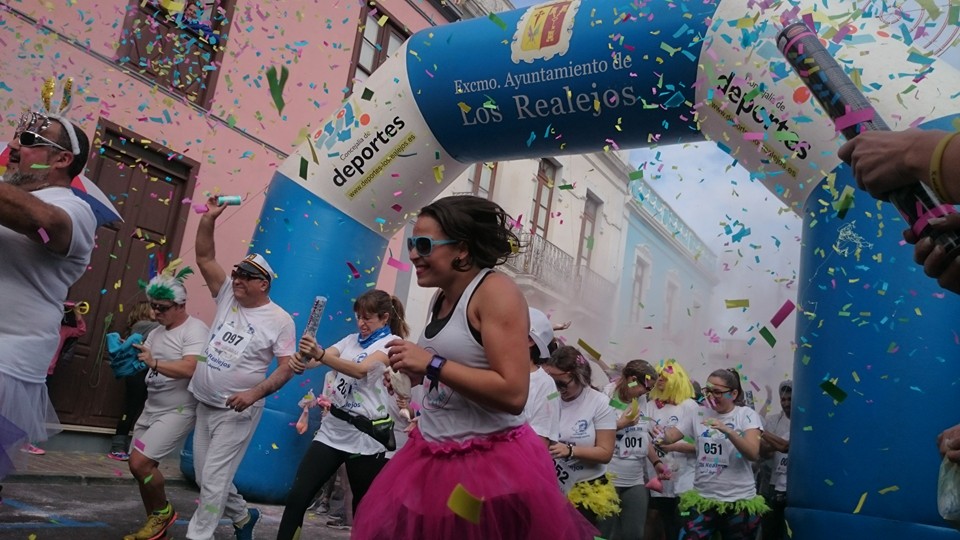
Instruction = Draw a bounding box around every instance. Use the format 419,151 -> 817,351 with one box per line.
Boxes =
183,0 -> 960,539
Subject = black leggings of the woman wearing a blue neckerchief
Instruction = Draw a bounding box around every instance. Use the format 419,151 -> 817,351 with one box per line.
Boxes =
277,441 -> 387,540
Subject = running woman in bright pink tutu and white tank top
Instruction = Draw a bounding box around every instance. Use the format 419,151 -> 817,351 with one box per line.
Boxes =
352,196 -> 597,540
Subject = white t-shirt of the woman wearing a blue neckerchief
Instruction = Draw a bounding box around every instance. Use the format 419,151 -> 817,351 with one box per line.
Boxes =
314,334 -> 399,456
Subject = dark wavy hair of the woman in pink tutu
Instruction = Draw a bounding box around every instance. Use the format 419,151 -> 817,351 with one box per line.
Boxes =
420,195 -> 520,272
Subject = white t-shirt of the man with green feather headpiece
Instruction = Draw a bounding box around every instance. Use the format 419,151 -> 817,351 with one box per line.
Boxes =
143,317 -> 210,412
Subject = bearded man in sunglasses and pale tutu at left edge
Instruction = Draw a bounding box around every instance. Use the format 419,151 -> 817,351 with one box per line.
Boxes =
0,113 -> 97,486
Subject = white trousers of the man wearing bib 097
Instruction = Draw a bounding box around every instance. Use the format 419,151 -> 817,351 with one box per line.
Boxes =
187,403 -> 263,540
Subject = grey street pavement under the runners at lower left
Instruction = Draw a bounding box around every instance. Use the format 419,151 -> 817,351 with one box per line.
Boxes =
0,479 -> 350,540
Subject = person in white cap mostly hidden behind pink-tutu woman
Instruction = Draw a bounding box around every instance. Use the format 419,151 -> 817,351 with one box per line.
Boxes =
523,308 -> 560,446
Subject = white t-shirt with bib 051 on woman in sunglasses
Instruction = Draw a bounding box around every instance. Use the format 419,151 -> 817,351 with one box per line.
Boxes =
684,406 -> 763,502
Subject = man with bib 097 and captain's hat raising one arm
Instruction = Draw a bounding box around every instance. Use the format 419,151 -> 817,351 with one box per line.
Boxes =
187,197 -> 297,540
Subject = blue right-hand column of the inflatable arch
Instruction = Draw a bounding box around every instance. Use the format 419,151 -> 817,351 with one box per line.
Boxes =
787,112 -> 960,540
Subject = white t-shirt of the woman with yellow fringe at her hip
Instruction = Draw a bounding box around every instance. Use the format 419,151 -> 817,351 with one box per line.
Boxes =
554,388 -> 617,493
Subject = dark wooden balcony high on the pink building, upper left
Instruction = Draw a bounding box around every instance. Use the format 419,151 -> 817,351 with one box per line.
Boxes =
117,2 -> 225,108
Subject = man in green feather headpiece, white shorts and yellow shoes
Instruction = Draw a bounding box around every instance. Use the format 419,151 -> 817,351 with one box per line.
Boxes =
124,268 -> 210,540
